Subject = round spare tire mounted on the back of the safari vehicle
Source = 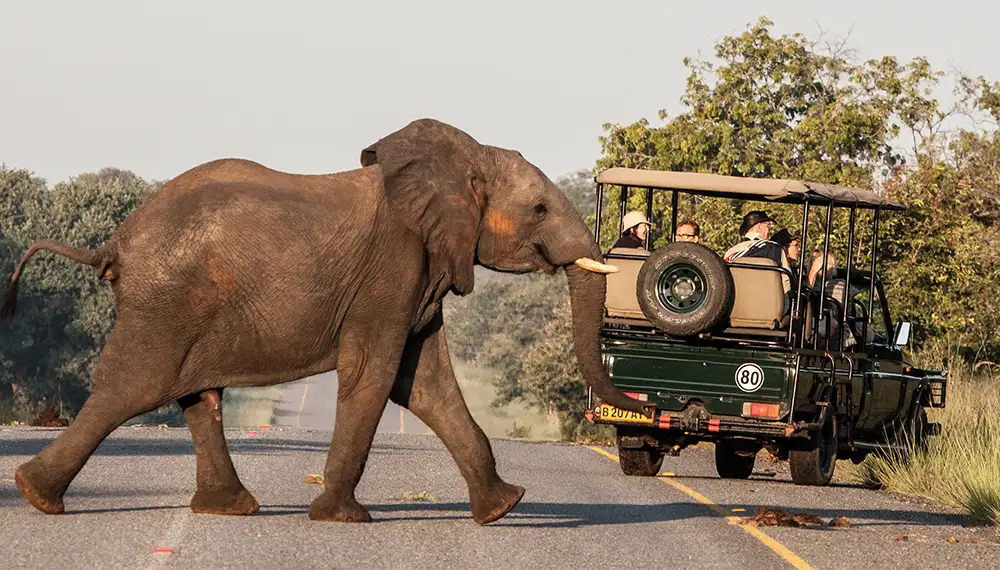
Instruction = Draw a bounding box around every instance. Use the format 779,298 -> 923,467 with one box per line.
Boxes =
636,242 -> 736,337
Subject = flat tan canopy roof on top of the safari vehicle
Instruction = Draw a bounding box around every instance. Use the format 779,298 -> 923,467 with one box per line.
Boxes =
597,167 -> 906,210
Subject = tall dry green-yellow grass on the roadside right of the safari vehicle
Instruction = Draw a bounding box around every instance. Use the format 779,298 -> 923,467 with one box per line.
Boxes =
838,367 -> 1000,531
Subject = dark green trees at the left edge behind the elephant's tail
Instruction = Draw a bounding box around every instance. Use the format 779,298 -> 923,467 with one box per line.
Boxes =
0,168 -> 154,415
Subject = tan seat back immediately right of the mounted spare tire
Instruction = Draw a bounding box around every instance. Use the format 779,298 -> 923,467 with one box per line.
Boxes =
729,257 -> 787,330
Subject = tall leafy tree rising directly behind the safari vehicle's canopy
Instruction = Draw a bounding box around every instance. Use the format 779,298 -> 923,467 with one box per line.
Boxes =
596,18 -> 947,259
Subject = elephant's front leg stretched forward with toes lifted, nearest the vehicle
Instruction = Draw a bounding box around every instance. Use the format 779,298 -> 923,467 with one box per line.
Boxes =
392,313 -> 524,524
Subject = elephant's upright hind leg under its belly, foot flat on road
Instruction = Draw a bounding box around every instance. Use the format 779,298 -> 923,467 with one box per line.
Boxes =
177,389 -> 260,515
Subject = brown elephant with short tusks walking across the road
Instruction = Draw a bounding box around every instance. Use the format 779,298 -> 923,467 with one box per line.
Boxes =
0,118 -> 651,525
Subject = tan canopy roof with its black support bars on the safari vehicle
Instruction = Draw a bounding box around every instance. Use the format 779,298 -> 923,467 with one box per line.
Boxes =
594,168 -> 905,353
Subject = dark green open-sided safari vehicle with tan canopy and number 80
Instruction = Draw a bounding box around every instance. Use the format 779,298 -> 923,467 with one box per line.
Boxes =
585,168 -> 947,485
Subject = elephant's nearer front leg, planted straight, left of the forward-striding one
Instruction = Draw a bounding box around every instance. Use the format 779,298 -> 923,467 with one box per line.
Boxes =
309,325 -> 406,522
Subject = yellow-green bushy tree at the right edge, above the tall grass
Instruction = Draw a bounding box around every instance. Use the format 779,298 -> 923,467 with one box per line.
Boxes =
881,115 -> 1000,361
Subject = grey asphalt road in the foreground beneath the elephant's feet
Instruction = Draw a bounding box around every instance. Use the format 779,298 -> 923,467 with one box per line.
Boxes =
0,427 -> 1000,569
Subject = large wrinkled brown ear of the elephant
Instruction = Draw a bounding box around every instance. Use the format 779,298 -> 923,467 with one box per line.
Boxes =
361,119 -> 486,295
